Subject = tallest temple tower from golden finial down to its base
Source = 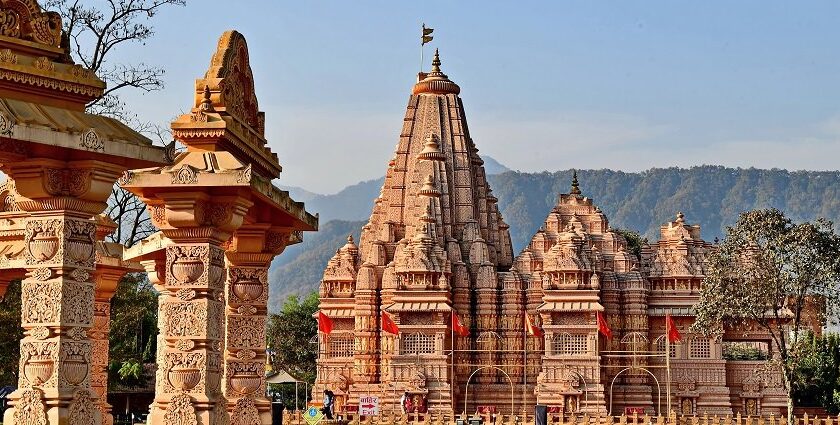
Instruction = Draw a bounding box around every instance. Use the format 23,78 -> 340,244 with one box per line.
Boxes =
314,48 -> 513,413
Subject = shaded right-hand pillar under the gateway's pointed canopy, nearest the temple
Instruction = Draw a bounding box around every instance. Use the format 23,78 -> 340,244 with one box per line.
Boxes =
222,224 -> 291,425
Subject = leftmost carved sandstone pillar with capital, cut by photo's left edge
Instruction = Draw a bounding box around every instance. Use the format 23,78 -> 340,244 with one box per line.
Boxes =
4,158 -> 122,424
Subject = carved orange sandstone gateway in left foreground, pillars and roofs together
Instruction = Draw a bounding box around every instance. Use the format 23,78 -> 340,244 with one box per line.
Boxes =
0,0 -> 318,425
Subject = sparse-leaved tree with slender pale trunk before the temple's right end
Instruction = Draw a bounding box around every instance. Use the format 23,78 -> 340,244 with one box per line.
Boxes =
693,209 -> 840,420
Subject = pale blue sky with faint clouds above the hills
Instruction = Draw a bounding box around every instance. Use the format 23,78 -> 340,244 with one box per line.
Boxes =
113,0 -> 840,193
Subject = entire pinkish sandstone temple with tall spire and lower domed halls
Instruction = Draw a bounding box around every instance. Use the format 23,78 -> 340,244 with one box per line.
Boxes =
314,52 -> 786,415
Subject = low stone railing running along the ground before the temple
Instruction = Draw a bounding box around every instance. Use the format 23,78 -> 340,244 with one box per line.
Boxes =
283,411 -> 840,425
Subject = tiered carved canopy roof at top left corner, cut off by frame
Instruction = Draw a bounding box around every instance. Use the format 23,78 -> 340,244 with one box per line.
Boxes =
0,0 -> 165,168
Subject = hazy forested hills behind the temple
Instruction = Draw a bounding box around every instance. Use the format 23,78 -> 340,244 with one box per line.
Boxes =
270,166 -> 840,309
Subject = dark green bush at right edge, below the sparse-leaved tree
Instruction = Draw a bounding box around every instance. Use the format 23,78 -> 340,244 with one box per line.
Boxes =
793,332 -> 840,415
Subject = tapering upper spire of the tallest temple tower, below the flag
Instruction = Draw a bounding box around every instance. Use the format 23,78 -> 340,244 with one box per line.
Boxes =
360,51 -> 513,269
